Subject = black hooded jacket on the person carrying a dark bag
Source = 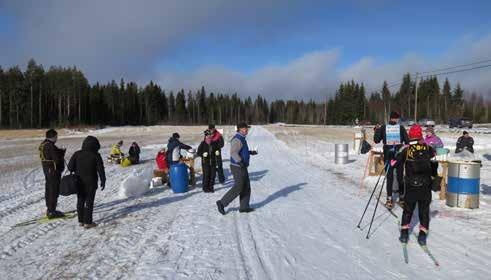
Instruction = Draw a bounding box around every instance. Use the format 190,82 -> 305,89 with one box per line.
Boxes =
68,136 -> 106,189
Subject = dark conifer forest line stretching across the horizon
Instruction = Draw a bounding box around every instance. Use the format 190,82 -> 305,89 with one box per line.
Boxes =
0,59 -> 491,128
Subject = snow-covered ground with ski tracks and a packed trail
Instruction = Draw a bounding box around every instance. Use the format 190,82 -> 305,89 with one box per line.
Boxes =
0,126 -> 491,279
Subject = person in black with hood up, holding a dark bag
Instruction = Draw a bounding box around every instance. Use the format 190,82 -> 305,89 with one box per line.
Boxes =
68,136 -> 106,228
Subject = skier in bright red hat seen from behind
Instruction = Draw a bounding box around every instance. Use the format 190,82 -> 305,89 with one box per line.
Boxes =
396,124 -> 438,245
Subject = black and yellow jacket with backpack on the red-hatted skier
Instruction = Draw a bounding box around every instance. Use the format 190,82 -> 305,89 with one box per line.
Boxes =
396,142 -> 438,202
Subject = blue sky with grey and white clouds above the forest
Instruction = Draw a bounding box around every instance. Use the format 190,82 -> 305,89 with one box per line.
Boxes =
0,0 -> 491,97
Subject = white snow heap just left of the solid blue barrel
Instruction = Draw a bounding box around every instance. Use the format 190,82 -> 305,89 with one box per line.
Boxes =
119,168 -> 152,198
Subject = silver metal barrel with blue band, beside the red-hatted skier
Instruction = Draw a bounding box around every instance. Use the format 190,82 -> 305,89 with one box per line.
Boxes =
447,161 -> 481,209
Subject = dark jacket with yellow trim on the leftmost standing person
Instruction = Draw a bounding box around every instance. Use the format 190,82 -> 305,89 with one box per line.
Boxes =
39,139 -> 65,176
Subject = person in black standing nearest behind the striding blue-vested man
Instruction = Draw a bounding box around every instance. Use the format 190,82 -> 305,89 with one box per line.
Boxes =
198,129 -> 220,192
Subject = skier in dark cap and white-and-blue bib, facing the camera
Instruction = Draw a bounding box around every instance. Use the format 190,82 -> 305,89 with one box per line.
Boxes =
373,112 -> 409,209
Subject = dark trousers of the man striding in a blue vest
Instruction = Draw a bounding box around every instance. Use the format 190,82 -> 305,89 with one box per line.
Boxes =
221,165 -> 251,210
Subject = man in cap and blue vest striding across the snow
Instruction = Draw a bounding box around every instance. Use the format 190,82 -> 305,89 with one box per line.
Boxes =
216,123 -> 257,215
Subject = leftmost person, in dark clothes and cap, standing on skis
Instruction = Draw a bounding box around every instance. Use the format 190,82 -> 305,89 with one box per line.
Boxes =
39,129 -> 66,219
